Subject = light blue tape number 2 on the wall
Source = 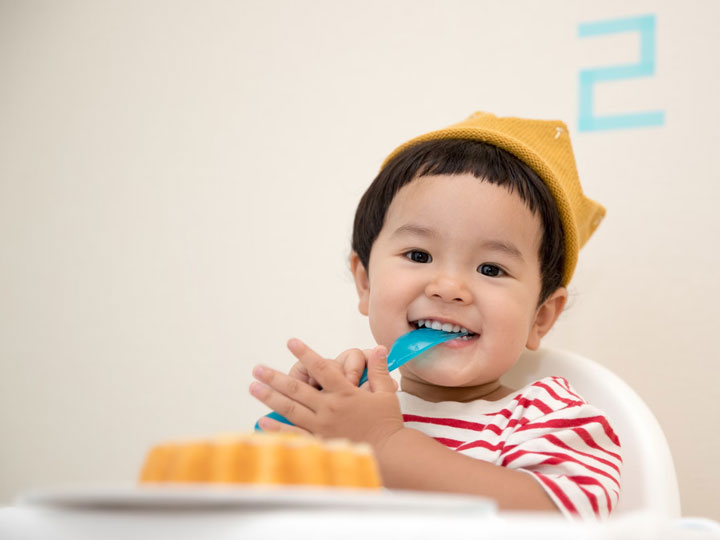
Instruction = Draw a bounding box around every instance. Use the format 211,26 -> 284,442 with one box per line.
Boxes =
578,15 -> 665,131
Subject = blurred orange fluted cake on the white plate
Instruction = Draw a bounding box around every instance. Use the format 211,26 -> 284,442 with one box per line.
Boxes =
140,432 -> 381,488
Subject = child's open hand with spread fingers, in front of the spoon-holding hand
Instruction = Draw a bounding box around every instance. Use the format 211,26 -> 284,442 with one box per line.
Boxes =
250,340 -> 403,447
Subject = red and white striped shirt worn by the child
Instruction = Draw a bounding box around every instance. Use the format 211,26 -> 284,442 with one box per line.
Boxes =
398,377 -> 622,519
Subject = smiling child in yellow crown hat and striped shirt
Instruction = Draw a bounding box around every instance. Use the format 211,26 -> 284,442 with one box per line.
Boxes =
250,113 -> 622,517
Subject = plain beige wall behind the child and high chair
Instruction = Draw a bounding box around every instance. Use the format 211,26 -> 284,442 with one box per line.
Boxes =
0,0 -> 720,519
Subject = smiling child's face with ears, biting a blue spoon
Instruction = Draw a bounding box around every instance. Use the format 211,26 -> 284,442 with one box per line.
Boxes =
353,174 -> 565,396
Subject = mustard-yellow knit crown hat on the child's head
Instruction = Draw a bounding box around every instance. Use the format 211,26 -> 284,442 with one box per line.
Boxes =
382,112 -> 605,285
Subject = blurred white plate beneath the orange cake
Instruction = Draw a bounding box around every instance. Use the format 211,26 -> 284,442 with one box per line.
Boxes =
16,485 -> 496,515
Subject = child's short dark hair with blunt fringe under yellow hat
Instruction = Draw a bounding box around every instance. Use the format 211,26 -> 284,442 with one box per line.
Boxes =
352,139 -> 565,305
